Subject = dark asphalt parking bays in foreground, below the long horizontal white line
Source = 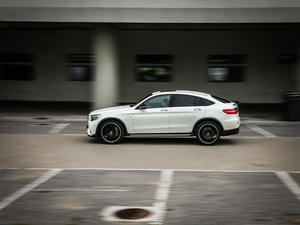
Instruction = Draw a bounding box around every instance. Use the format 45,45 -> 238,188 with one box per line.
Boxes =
0,169 -> 300,225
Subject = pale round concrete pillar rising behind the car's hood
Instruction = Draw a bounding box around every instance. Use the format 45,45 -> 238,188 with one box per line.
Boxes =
92,28 -> 119,110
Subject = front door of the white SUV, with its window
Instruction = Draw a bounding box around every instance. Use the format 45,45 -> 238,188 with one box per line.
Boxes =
133,95 -> 171,133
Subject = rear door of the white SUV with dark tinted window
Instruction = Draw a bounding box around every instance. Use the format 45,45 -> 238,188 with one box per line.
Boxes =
170,94 -> 206,133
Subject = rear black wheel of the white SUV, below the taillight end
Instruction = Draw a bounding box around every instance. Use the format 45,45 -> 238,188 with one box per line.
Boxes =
196,121 -> 220,145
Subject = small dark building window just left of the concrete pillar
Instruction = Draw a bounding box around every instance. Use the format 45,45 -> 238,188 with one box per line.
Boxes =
67,54 -> 94,81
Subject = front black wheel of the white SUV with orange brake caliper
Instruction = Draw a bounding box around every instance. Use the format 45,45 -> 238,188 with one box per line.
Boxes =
99,121 -> 124,144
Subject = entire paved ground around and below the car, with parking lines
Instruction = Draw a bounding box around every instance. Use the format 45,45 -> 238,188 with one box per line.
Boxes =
0,121 -> 300,225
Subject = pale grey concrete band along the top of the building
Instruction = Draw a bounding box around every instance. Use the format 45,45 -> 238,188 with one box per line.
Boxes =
0,0 -> 300,23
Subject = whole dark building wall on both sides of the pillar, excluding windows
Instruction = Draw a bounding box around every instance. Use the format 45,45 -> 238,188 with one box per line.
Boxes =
0,29 -> 299,104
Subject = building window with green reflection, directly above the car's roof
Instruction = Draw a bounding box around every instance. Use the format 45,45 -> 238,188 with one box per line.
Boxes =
135,55 -> 173,82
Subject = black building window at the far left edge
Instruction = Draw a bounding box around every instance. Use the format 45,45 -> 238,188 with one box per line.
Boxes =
0,53 -> 35,81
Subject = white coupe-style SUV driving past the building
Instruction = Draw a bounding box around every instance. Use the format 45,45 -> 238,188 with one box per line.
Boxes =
87,91 -> 241,145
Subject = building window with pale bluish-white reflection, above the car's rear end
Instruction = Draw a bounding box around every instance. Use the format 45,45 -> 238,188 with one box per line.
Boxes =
207,55 -> 246,82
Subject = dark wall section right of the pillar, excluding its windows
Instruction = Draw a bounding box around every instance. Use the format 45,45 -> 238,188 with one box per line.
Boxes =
120,30 -> 298,103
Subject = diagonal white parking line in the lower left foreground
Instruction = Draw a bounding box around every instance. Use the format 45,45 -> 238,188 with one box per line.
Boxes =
0,169 -> 62,211
